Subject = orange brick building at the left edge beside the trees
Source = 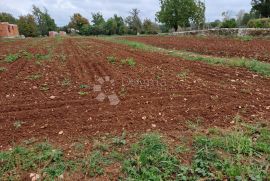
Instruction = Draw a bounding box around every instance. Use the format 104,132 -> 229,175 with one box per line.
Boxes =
0,22 -> 19,38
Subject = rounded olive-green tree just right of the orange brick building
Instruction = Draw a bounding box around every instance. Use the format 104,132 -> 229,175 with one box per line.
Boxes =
17,14 -> 38,37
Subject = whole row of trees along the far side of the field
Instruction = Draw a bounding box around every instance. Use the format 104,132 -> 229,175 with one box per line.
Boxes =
0,0 -> 270,37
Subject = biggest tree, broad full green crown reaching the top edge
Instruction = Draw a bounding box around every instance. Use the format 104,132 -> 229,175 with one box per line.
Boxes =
156,0 -> 205,31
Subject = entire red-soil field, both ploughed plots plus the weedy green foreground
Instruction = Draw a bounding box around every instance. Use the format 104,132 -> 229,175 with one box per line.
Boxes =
0,36 -> 270,180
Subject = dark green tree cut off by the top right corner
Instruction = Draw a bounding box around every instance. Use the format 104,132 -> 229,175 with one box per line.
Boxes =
251,0 -> 270,18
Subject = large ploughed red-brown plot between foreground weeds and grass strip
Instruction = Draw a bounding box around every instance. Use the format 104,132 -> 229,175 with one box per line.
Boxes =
0,38 -> 270,149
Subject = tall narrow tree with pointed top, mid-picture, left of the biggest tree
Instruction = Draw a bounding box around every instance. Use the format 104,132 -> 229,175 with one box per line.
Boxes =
126,9 -> 142,34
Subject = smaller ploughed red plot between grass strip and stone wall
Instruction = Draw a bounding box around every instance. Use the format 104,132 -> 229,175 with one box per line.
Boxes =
125,36 -> 270,62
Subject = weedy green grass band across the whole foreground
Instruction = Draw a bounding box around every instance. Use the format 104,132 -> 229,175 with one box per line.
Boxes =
0,121 -> 270,181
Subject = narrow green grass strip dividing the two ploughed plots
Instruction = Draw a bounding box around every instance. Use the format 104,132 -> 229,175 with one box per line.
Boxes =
102,37 -> 270,76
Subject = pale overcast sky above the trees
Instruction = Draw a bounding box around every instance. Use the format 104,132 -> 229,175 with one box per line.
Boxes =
0,0 -> 251,26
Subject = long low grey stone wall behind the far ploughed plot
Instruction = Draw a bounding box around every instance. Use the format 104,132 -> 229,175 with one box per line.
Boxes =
172,28 -> 270,36
